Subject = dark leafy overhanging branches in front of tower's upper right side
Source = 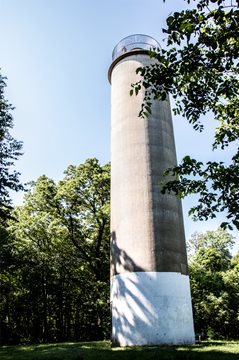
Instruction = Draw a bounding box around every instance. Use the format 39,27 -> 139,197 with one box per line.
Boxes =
131,0 -> 239,229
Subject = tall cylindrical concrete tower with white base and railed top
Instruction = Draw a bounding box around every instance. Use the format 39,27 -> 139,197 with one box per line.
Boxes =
109,35 -> 194,346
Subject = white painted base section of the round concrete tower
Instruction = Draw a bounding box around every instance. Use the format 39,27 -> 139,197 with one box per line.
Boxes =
111,272 -> 195,346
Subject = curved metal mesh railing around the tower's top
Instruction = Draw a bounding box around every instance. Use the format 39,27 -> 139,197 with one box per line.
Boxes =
112,34 -> 160,61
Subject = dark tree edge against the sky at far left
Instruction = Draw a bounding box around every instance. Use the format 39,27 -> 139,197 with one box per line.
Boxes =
0,74 -> 23,220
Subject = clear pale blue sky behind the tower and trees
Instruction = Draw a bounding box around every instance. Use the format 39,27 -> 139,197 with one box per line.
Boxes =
0,0 -> 236,250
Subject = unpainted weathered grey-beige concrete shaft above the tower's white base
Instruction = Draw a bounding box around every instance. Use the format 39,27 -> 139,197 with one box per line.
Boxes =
111,54 -> 187,274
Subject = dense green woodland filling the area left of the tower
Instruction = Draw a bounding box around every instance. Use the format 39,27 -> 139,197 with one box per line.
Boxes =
0,159 -> 110,343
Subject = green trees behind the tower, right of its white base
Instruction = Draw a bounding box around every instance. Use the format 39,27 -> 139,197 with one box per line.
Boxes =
189,229 -> 239,339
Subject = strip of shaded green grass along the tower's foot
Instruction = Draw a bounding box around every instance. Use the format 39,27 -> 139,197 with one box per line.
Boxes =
0,341 -> 239,360
